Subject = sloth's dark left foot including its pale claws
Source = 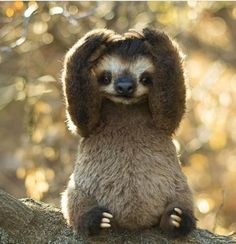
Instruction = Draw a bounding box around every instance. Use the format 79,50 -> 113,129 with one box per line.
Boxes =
78,207 -> 113,235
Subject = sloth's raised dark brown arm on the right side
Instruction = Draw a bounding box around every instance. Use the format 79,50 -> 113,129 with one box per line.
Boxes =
143,28 -> 186,134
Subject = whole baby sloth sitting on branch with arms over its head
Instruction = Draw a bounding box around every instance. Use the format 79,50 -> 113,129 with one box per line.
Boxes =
62,28 -> 196,237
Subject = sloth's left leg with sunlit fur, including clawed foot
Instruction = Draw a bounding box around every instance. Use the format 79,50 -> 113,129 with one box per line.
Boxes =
61,176 -> 112,235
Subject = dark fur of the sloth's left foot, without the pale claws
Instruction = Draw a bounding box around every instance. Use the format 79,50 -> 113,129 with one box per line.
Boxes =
78,207 -> 109,235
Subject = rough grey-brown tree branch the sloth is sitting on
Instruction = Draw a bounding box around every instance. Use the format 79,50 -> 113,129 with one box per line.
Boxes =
0,190 -> 236,244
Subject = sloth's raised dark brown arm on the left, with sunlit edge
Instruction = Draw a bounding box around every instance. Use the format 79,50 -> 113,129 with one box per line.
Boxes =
62,29 -> 114,137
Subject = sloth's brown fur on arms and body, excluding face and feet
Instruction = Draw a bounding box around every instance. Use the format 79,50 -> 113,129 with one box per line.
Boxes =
62,29 -> 193,236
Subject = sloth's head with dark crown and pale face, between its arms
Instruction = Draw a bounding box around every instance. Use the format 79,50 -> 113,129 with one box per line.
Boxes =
93,41 -> 155,104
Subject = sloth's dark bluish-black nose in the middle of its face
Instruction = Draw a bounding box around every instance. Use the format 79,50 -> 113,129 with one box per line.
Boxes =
115,77 -> 135,96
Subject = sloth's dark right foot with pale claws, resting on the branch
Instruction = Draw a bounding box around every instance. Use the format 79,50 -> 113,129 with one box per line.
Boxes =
160,204 -> 196,238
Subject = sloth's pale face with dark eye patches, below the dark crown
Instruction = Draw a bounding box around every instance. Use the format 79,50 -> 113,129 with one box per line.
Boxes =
94,55 -> 154,104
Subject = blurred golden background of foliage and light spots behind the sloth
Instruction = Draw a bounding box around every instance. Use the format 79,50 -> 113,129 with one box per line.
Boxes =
0,1 -> 236,235
